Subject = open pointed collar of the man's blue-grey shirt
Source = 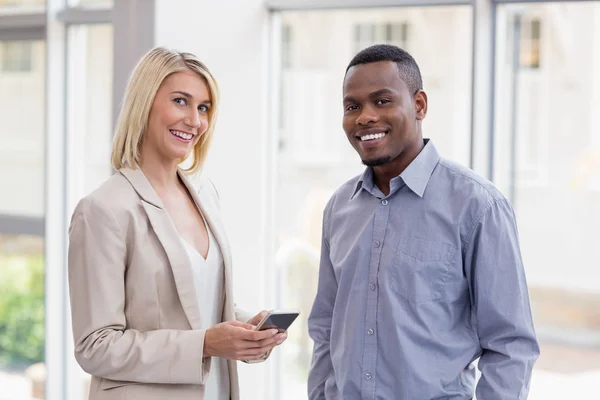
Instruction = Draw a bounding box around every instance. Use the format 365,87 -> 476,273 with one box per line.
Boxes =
350,139 -> 440,200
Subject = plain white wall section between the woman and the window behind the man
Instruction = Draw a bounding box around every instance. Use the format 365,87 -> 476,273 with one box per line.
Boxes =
155,0 -> 272,399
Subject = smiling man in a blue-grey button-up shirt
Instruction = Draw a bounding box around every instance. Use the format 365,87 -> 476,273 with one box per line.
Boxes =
308,45 -> 539,400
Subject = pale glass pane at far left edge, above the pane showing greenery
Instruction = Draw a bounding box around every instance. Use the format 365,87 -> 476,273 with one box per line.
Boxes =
0,41 -> 46,217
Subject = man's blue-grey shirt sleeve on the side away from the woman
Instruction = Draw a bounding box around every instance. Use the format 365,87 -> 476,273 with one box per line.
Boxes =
465,199 -> 539,400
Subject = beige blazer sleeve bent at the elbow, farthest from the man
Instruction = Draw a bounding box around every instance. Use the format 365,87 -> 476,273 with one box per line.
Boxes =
68,198 -> 210,384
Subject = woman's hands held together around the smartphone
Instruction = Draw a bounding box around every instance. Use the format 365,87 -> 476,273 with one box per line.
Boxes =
204,317 -> 285,360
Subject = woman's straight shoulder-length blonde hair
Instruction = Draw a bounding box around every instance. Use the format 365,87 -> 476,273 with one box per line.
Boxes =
111,47 -> 219,173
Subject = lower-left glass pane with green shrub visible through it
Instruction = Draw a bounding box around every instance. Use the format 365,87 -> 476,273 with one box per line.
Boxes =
0,233 -> 45,400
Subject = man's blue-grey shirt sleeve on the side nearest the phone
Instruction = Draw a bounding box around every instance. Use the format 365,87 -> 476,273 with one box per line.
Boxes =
308,208 -> 338,400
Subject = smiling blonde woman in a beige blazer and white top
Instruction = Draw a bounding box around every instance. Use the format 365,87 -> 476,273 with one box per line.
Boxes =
69,48 -> 286,400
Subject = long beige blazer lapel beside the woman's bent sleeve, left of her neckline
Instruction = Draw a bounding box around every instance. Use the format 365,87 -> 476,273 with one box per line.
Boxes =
119,168 -> 201,329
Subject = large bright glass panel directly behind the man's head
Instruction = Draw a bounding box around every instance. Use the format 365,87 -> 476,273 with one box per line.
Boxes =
275,6 -> 472,400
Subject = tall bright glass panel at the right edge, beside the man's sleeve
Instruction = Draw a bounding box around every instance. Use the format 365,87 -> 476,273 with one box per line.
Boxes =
495,2 -> 600,400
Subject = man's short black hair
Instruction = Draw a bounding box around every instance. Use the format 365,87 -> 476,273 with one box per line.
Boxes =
346,44 -> 423,95
